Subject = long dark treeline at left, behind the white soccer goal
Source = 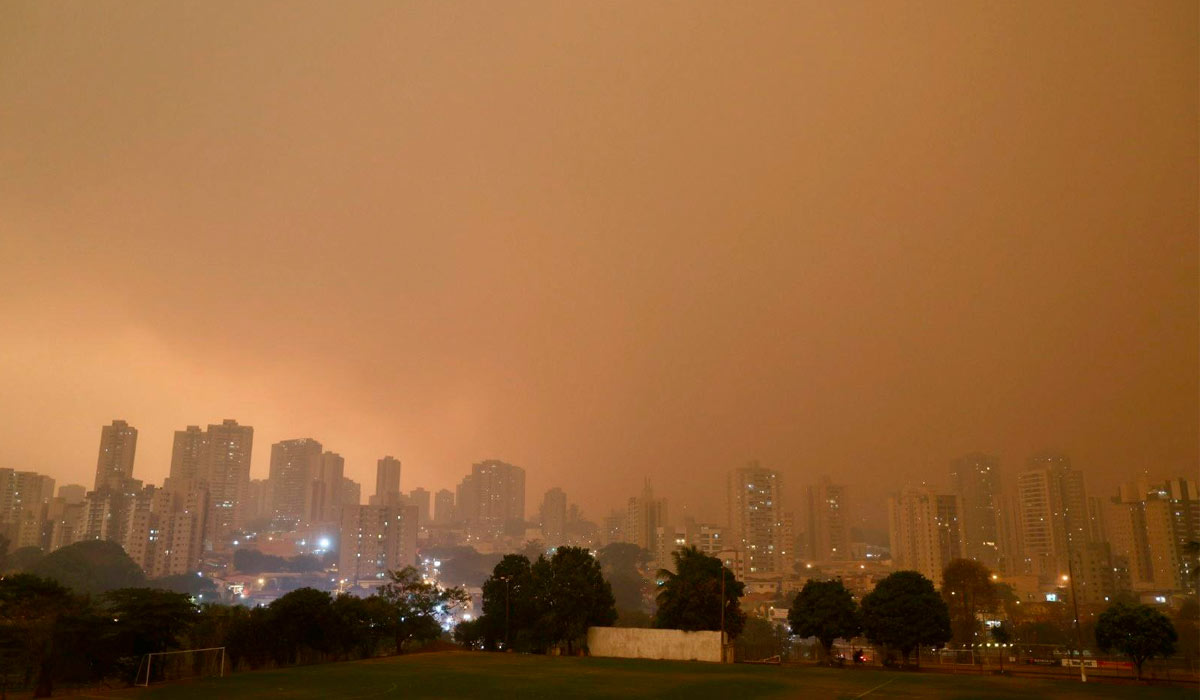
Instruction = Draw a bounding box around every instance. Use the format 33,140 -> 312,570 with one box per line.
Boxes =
0,567 -> 467,698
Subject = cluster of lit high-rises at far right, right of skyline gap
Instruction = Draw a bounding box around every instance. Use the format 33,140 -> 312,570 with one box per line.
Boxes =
888,453 -> 1200,605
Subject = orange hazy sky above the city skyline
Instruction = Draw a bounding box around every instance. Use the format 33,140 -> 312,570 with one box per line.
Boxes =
0,0 -> 1200,525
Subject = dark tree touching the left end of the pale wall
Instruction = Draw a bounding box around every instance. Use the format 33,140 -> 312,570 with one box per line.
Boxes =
532,546 -> 617,654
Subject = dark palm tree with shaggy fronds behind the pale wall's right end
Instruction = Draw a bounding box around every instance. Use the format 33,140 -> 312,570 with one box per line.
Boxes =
654,546 -> 746,638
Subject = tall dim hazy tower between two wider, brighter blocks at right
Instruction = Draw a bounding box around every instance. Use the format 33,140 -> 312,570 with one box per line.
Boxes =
950,453 -> 1000,569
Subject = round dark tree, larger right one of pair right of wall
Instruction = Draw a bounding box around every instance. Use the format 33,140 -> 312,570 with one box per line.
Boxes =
863,572 -> 952,665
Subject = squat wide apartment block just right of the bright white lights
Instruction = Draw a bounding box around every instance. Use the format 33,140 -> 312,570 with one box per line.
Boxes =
337,505 -> 418,584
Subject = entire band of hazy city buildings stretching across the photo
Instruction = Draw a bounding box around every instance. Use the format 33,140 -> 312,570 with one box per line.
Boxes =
0,420 -> 1200,604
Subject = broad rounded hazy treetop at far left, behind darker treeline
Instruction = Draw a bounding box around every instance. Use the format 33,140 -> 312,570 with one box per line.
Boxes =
29,539 -> 145,594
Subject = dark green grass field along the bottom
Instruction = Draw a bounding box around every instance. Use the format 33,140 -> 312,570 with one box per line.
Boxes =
120,652 -> 1196,700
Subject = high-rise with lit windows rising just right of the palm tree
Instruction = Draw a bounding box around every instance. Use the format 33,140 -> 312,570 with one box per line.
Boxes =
726,461 -> 788,574
